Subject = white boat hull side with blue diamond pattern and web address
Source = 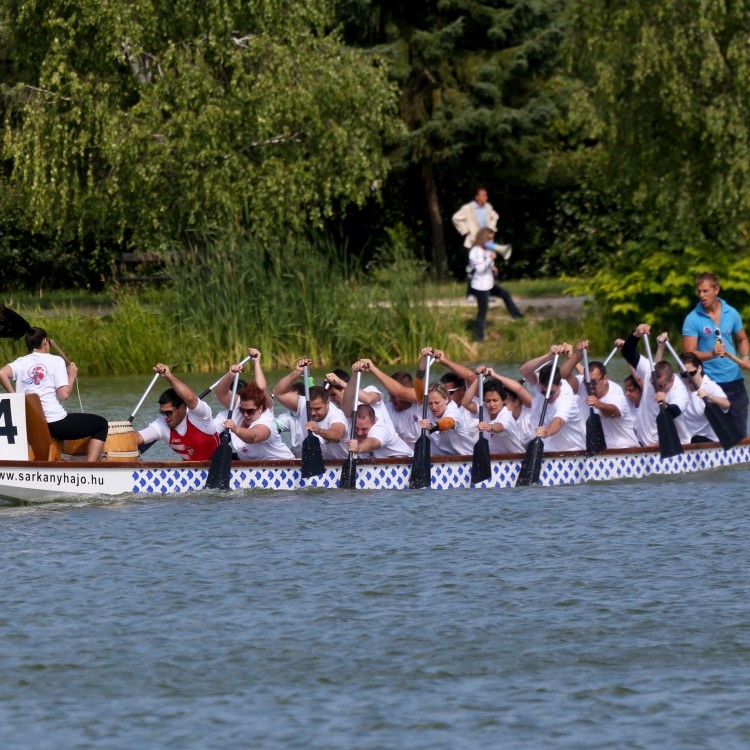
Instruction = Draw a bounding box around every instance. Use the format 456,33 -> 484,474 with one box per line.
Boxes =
0,440 -> 750,503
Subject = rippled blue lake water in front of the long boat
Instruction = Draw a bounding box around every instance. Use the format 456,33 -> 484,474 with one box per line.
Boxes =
0,379 -> 750,750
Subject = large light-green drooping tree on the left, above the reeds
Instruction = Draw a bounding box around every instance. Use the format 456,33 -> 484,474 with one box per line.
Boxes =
0,0 -> 395,270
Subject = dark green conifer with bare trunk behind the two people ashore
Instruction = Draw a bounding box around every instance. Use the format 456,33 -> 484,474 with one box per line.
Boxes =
338,0 -> 562,276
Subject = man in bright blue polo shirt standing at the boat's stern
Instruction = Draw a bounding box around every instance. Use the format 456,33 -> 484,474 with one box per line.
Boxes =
682,273 -> 750,437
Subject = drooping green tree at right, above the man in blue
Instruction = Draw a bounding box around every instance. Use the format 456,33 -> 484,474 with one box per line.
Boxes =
569,0 -> 750,247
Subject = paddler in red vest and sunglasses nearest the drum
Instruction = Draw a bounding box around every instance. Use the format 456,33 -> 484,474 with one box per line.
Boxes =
135,362 -> 219,461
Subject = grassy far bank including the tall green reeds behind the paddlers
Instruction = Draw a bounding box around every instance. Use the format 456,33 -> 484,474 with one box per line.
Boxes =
0,232 -> 605,375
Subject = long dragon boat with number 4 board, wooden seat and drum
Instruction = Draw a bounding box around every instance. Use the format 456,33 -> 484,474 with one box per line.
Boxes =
0,394 -> 750,503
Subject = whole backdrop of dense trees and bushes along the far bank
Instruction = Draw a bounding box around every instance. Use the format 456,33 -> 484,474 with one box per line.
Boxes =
0,0 -> 750,347
